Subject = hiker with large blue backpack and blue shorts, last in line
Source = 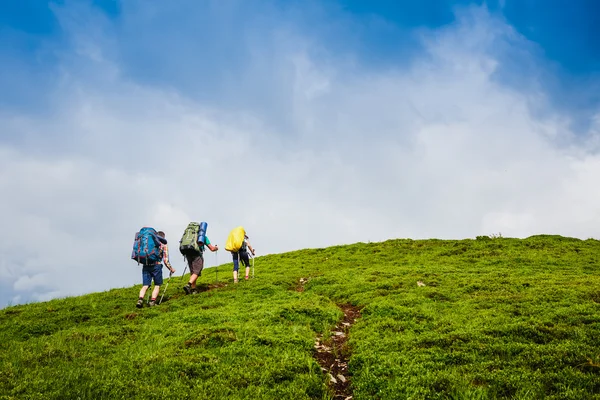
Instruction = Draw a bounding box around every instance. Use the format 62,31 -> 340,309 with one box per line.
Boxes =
132,228 -> 175,308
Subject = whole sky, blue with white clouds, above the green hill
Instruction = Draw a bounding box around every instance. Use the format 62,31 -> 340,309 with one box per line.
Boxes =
0,0 -> 600,307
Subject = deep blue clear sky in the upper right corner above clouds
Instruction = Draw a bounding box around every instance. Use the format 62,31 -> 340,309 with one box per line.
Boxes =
342,0 -> 600,74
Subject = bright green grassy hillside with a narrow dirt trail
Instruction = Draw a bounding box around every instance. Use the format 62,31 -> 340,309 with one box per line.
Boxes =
0,236 -> 600,399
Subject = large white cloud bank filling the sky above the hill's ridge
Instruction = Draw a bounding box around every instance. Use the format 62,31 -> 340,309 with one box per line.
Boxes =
0,4 -> 600,308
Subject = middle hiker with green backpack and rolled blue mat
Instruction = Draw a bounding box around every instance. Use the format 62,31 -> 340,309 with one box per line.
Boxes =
179,222 -> 219,294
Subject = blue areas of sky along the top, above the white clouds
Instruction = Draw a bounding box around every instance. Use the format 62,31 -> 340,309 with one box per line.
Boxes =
0,0 -> 600,122
